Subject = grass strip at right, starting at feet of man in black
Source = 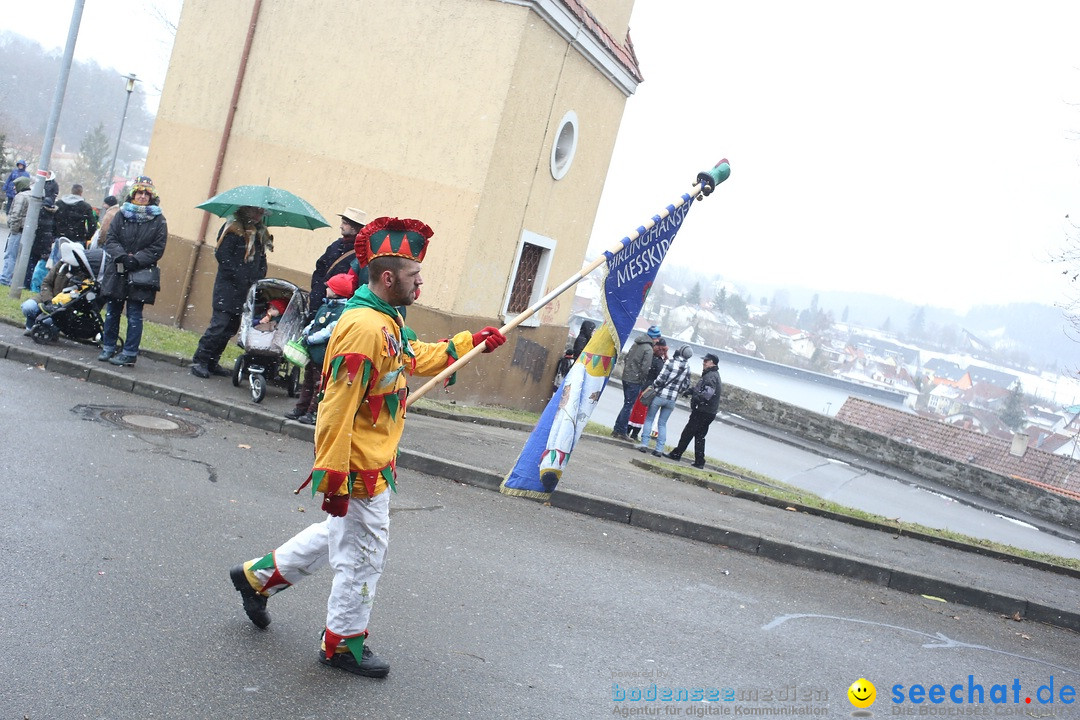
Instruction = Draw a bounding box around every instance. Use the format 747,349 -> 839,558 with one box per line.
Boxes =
646,458 -> 1080,570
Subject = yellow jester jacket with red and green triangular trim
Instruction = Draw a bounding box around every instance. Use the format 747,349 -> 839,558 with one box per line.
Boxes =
311,295 -> 473,505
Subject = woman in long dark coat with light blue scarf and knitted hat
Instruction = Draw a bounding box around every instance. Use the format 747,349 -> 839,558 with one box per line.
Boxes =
97,176 -> 168,365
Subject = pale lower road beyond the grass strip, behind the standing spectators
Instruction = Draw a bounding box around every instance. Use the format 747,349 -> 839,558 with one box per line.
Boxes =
592,385 -> 1080,558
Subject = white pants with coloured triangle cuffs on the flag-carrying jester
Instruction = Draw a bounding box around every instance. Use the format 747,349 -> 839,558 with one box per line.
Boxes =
252,490 -> 390,637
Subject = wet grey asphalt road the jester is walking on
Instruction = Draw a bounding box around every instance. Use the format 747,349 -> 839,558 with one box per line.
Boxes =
0,362 -> 1080,720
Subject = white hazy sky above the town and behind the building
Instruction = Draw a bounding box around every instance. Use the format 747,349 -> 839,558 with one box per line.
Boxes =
8,0 -> 1080,310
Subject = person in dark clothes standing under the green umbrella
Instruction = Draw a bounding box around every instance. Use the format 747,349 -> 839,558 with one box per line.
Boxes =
191,205 -> 273,378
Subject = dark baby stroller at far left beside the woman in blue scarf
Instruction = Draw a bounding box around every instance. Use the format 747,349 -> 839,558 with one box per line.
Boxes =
30,242 -> 106,344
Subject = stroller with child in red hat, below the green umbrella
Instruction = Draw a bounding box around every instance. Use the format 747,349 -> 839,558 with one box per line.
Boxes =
232,277 -> 308,403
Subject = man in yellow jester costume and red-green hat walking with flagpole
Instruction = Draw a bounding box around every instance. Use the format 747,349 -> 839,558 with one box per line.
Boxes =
229,217 -> 505,678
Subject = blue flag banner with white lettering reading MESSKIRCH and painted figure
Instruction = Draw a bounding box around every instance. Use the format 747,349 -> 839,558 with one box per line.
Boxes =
499,194 -> 693,500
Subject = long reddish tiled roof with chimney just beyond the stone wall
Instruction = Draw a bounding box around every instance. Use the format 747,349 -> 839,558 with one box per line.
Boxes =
836,397 -> 1080,494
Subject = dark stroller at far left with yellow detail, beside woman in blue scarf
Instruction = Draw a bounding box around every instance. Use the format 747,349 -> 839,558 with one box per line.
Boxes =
22,237 -> 105,343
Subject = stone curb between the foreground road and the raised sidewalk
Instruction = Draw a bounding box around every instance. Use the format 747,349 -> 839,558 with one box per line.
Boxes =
6,334 -> 1080,631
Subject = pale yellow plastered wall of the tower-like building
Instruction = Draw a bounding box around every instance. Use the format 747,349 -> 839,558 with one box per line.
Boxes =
146,0 -> 632,408
